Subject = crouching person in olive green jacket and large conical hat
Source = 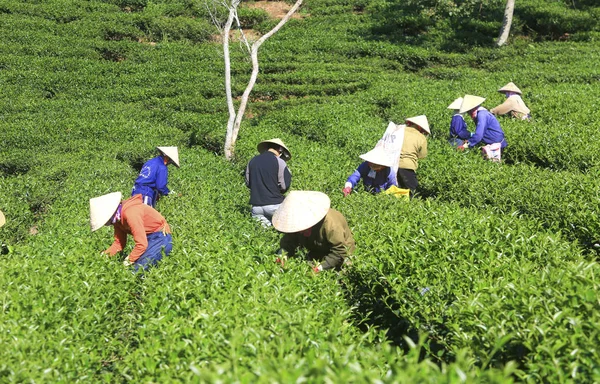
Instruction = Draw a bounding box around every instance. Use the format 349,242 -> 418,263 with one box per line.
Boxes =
273,191 -> 355,273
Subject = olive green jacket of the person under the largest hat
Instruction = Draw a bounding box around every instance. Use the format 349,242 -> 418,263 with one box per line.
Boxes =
279,208 -> 355,269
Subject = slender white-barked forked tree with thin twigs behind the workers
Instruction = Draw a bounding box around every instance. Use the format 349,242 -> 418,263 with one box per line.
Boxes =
211,0 -> 303,160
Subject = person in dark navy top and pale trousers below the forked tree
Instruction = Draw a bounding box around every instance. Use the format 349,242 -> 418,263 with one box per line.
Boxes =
246,138 -> 292,227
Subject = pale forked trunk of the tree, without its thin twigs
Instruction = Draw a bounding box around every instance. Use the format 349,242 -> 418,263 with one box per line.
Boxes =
223,0 -> 303,161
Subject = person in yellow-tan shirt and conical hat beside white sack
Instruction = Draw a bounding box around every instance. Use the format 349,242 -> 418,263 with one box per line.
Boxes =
396,115 -> 431,197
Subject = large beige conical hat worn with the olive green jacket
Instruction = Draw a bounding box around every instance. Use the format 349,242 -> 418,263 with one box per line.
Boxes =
273,191 -> 331,233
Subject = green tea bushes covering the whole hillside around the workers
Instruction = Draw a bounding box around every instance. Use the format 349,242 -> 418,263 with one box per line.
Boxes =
0,0 -> 600,383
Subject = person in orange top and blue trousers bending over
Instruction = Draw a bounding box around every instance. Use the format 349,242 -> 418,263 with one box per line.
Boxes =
90,192 -> 173,272
